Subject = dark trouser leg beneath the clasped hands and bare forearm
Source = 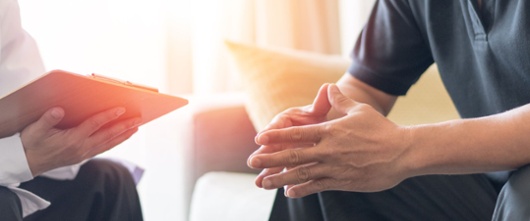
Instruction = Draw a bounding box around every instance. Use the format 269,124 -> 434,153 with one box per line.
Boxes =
270,174 -> 499,221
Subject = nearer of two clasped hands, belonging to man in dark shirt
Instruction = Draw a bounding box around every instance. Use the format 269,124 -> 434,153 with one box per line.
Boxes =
248,85 -> 412,197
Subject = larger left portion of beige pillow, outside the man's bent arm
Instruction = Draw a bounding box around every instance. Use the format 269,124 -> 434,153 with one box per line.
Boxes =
226,41 -> 349,131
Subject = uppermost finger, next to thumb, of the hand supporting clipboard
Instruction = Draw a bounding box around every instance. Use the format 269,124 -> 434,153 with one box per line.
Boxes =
74,107 -> 125,137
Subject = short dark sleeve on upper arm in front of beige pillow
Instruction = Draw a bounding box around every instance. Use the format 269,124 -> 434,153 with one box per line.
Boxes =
348,0 -> 433,95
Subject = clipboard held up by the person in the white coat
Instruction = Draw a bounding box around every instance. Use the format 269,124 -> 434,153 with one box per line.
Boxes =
0,70 -> 188,137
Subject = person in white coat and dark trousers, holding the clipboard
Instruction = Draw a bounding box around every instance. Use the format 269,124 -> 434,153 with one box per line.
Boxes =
0,0 -> 143,221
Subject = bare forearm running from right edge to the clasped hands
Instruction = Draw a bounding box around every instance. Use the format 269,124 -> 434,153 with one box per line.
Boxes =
406,105 -> 530,175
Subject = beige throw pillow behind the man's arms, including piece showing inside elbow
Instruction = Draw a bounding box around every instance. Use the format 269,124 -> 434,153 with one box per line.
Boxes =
226,41 -> 458,131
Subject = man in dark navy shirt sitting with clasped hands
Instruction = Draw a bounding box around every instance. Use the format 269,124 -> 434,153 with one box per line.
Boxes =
248,0 -> 530,220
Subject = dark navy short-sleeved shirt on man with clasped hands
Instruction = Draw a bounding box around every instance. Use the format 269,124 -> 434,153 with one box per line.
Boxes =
349,0 -> 530,118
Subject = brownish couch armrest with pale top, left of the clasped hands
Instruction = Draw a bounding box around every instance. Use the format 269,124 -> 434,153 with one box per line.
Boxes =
190,94 -> 258,180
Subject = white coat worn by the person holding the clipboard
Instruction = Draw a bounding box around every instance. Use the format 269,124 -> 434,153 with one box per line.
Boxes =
0,0 -> 84,216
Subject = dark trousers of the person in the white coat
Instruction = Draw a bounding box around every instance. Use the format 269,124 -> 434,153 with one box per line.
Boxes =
0,159 -> 143,221
